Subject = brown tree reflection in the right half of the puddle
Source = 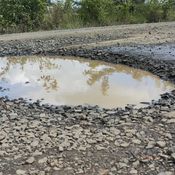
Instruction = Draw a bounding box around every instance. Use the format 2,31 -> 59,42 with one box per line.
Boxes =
84,61 -> 169,95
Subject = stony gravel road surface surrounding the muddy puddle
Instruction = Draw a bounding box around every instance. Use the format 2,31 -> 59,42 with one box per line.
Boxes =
0,23 -> 175,175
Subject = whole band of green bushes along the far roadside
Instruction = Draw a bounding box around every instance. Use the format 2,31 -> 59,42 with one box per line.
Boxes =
0,0 -> 175,33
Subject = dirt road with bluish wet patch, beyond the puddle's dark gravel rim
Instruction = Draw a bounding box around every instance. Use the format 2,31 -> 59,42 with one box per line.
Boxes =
0,22 -> 175,60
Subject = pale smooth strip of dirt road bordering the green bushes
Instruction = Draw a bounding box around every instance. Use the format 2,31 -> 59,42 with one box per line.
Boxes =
0,22 -> 175,45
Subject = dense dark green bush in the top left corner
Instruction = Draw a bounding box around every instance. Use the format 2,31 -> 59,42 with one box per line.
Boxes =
0,0 -> 46,31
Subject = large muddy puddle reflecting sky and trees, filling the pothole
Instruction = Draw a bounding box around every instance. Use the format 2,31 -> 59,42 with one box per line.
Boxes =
0,57 -> 174,108
